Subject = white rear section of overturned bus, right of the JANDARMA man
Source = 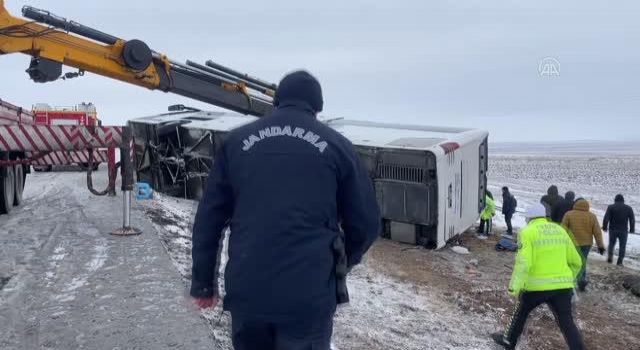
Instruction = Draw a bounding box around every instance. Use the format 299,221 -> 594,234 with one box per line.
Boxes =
329,120 -> 488,248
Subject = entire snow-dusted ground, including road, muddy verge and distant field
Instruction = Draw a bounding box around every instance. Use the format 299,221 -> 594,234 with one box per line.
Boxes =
0,144 -> 640,350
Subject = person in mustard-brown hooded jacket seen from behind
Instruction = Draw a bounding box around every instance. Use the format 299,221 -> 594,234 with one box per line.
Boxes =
562,198 -> 605,292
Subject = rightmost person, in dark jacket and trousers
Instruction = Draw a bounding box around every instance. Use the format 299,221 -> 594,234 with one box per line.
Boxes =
602,194 -> 636,266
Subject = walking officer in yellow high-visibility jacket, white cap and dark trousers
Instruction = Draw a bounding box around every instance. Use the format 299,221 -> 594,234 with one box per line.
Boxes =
491,203 -> 584,350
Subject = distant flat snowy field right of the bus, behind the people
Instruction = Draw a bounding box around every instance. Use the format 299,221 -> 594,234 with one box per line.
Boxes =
488,150 -> 640,269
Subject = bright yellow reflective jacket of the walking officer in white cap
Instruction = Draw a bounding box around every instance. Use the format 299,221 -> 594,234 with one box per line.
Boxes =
509,218 -> 582,295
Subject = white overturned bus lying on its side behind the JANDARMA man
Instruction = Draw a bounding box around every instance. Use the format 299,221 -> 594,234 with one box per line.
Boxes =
130,110 -> 488,248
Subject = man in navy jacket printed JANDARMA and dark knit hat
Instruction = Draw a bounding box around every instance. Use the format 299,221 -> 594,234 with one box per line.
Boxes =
191,71 -> 380,350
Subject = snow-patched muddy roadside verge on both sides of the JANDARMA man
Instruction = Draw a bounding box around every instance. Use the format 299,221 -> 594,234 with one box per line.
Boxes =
145,196 -> 640,350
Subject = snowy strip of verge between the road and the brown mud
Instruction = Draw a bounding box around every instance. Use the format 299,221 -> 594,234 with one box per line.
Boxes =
141,194 -> 495,350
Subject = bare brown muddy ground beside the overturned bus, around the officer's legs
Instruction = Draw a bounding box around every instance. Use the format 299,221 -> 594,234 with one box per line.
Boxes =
370,234 -> 640,350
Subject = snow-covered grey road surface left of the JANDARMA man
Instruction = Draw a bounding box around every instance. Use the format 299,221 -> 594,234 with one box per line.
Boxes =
0,170 -> 213,350
